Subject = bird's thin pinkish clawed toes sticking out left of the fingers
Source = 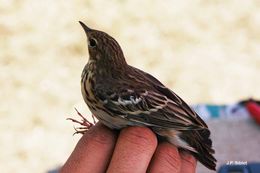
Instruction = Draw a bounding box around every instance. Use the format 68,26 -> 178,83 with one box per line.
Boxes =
67,108 -> 97,134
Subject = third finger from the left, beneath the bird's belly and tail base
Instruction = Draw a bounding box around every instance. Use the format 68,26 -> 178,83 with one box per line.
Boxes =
149,142 -> 181,173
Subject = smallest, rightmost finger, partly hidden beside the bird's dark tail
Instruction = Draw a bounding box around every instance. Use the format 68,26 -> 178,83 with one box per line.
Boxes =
180,151 -> 197,173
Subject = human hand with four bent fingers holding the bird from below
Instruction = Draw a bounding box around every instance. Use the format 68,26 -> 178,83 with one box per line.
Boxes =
60,123 -> 196,173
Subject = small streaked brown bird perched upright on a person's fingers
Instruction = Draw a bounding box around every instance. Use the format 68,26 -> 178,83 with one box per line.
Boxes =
80,22 -> 216,170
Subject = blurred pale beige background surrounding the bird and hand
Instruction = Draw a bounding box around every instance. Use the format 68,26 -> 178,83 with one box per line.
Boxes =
0,0 -> 260,173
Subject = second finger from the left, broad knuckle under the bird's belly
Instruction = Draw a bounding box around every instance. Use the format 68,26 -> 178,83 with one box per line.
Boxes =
107,127 -> 157,173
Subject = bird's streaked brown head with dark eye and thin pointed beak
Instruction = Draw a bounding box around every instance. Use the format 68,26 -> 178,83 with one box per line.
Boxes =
79,22 -> 126,69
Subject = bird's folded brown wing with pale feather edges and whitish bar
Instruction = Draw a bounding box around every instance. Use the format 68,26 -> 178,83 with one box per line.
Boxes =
95,79 -> 205,130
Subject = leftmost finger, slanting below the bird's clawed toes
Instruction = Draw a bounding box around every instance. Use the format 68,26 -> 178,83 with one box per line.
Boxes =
60,123 -> 117,173
